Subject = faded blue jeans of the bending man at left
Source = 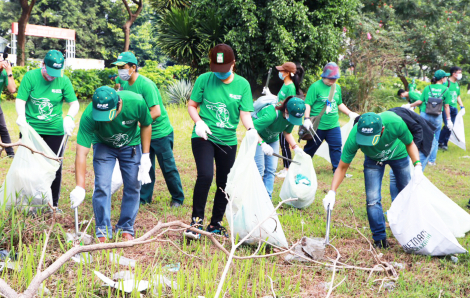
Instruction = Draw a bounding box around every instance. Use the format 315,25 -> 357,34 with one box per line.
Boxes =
93,143 -> 142,239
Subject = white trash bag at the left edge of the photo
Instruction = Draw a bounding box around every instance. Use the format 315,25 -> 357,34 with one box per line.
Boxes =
0,125 -> 60,208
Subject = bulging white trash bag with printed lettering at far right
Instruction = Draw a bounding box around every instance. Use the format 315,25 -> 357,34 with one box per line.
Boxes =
387,177 -> 468,256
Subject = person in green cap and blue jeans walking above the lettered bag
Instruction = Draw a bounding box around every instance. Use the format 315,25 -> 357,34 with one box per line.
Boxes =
410,69 -> 454,169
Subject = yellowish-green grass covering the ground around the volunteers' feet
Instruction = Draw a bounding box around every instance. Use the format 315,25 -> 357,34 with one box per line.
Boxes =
0,100 -> 470,297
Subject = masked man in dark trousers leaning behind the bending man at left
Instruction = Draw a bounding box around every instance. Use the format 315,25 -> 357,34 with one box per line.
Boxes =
113,52 -> 184,207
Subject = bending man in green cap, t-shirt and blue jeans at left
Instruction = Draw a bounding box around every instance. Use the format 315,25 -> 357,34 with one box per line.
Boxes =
70,86 -> 153,242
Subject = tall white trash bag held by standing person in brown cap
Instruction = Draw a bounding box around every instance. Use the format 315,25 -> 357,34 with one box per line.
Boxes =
225,130 -> 288,247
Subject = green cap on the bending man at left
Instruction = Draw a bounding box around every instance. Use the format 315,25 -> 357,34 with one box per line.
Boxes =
91,86 -> 119,121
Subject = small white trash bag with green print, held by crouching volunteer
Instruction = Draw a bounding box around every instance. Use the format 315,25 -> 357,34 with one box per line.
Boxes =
280,152 -> 318,208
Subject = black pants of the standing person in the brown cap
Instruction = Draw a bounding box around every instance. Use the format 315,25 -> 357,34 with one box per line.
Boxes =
191,138 -> 235,225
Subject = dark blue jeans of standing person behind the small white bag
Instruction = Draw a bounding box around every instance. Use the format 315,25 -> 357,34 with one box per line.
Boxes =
304,126 -> 342,173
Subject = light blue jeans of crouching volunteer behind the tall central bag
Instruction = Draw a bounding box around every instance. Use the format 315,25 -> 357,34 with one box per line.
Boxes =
255,141 -> 279,199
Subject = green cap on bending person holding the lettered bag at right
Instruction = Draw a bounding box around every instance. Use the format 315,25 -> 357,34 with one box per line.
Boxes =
356,113 -> 382,146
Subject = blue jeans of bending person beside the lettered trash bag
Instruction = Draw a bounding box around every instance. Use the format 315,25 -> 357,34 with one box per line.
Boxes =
364,156 -> 411,241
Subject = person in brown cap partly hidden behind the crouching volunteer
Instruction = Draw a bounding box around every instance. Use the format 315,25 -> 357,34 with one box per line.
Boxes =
263,62 -> 304,178
